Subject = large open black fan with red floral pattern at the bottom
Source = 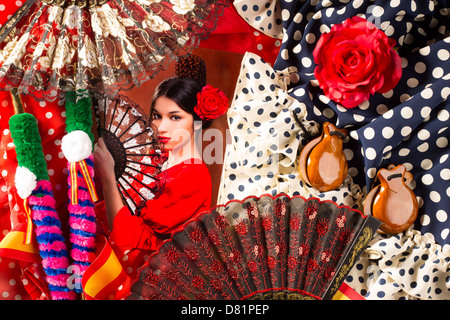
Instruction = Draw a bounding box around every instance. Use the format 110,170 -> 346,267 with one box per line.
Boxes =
128,194 -> 380,300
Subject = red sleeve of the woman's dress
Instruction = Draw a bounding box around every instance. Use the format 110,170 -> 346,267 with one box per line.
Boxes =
110,164 -> 211,250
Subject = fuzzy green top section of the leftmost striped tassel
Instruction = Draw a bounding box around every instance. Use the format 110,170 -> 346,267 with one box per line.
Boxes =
9,113 -> 49,181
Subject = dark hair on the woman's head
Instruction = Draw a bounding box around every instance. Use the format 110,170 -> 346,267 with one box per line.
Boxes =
150,77 -> 211,129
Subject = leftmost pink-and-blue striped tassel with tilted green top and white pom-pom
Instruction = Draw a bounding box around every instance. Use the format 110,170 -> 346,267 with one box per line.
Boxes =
9,113 -> 76,300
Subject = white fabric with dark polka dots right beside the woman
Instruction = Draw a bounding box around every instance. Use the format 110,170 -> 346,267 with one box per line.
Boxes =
218,53 -> 362,210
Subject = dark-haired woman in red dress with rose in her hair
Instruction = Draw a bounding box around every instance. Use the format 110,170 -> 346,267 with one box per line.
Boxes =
89,57 -> 228,298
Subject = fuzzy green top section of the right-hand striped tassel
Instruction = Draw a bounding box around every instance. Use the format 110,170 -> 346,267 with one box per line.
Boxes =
66,89 -> 94,145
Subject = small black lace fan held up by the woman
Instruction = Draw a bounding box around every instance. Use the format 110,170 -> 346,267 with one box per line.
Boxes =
93,95 -> 167,214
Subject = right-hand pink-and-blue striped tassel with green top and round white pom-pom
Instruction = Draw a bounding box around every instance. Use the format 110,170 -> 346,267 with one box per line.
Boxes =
61,90 -> 98,293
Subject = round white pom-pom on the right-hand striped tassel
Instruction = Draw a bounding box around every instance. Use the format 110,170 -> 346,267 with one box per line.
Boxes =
61,130 -> 92,162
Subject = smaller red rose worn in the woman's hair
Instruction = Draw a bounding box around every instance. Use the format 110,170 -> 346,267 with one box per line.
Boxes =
194,84 -> 228,120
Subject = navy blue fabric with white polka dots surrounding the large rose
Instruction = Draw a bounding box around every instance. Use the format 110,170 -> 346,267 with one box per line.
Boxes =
234,0 -> 450,245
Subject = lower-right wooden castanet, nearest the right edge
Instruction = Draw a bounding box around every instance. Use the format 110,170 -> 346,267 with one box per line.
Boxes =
364,165 -> 419,234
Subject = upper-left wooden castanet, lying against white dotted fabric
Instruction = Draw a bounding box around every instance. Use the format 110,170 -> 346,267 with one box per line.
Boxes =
299,122 -> 348,192
